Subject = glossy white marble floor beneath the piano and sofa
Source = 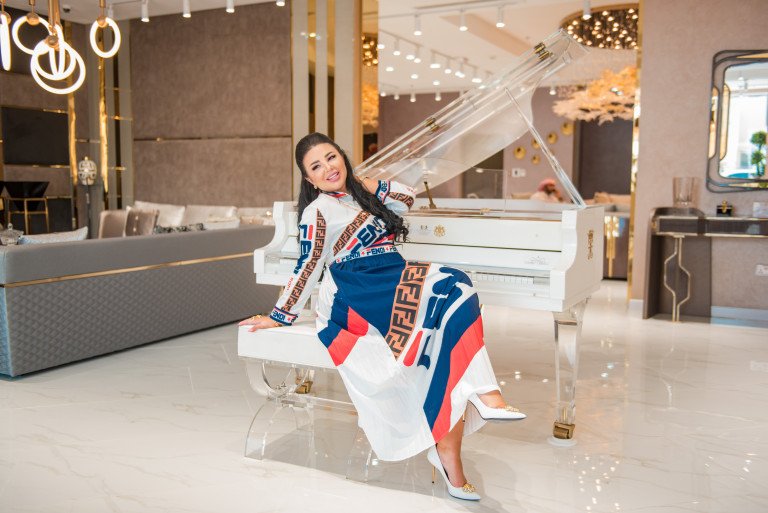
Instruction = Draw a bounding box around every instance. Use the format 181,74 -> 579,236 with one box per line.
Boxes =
0,282 -> 768,513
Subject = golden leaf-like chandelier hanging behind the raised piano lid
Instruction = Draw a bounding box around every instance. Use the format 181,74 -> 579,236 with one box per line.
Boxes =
552,66 -> 637,125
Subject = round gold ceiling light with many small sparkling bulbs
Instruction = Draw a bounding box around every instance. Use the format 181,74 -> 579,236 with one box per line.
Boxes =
560,4 -> 640,50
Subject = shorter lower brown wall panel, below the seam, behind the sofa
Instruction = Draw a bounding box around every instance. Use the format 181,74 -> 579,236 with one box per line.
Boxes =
134,135 -> 291,207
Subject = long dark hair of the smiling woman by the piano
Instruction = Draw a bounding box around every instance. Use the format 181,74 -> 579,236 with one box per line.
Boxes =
296,132 -> 408,241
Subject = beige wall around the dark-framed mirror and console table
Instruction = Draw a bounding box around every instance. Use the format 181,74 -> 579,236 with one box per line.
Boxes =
632,0 -> 768,309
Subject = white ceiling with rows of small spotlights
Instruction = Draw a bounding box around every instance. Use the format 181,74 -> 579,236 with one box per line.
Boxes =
6,0 -> 635,93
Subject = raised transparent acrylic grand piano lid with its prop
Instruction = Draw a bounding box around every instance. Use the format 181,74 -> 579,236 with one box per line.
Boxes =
355,30 -> 587,206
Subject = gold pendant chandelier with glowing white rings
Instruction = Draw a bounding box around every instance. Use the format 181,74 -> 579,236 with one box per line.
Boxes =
0,0 -> 120,94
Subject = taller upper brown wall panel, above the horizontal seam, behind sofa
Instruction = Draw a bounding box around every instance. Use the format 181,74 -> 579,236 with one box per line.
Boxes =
131,2 -> 291,140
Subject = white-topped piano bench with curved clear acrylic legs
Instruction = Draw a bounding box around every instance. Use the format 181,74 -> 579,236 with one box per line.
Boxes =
237,320 -> 378,482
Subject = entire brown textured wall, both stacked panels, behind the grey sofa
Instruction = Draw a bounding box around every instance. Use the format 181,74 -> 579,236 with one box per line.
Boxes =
131,3 -> 292,207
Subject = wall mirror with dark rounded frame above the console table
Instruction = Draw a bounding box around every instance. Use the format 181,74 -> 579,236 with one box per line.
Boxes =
707,50 -> 768,192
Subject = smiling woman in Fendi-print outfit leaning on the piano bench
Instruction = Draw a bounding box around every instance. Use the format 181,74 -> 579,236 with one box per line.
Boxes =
240,133 -> 525,500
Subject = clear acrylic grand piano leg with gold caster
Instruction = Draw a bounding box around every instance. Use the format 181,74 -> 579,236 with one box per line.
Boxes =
549,300 -> 587,445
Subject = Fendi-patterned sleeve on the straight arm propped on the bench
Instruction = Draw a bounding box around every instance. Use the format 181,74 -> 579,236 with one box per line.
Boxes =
270,205 -> 330,325
